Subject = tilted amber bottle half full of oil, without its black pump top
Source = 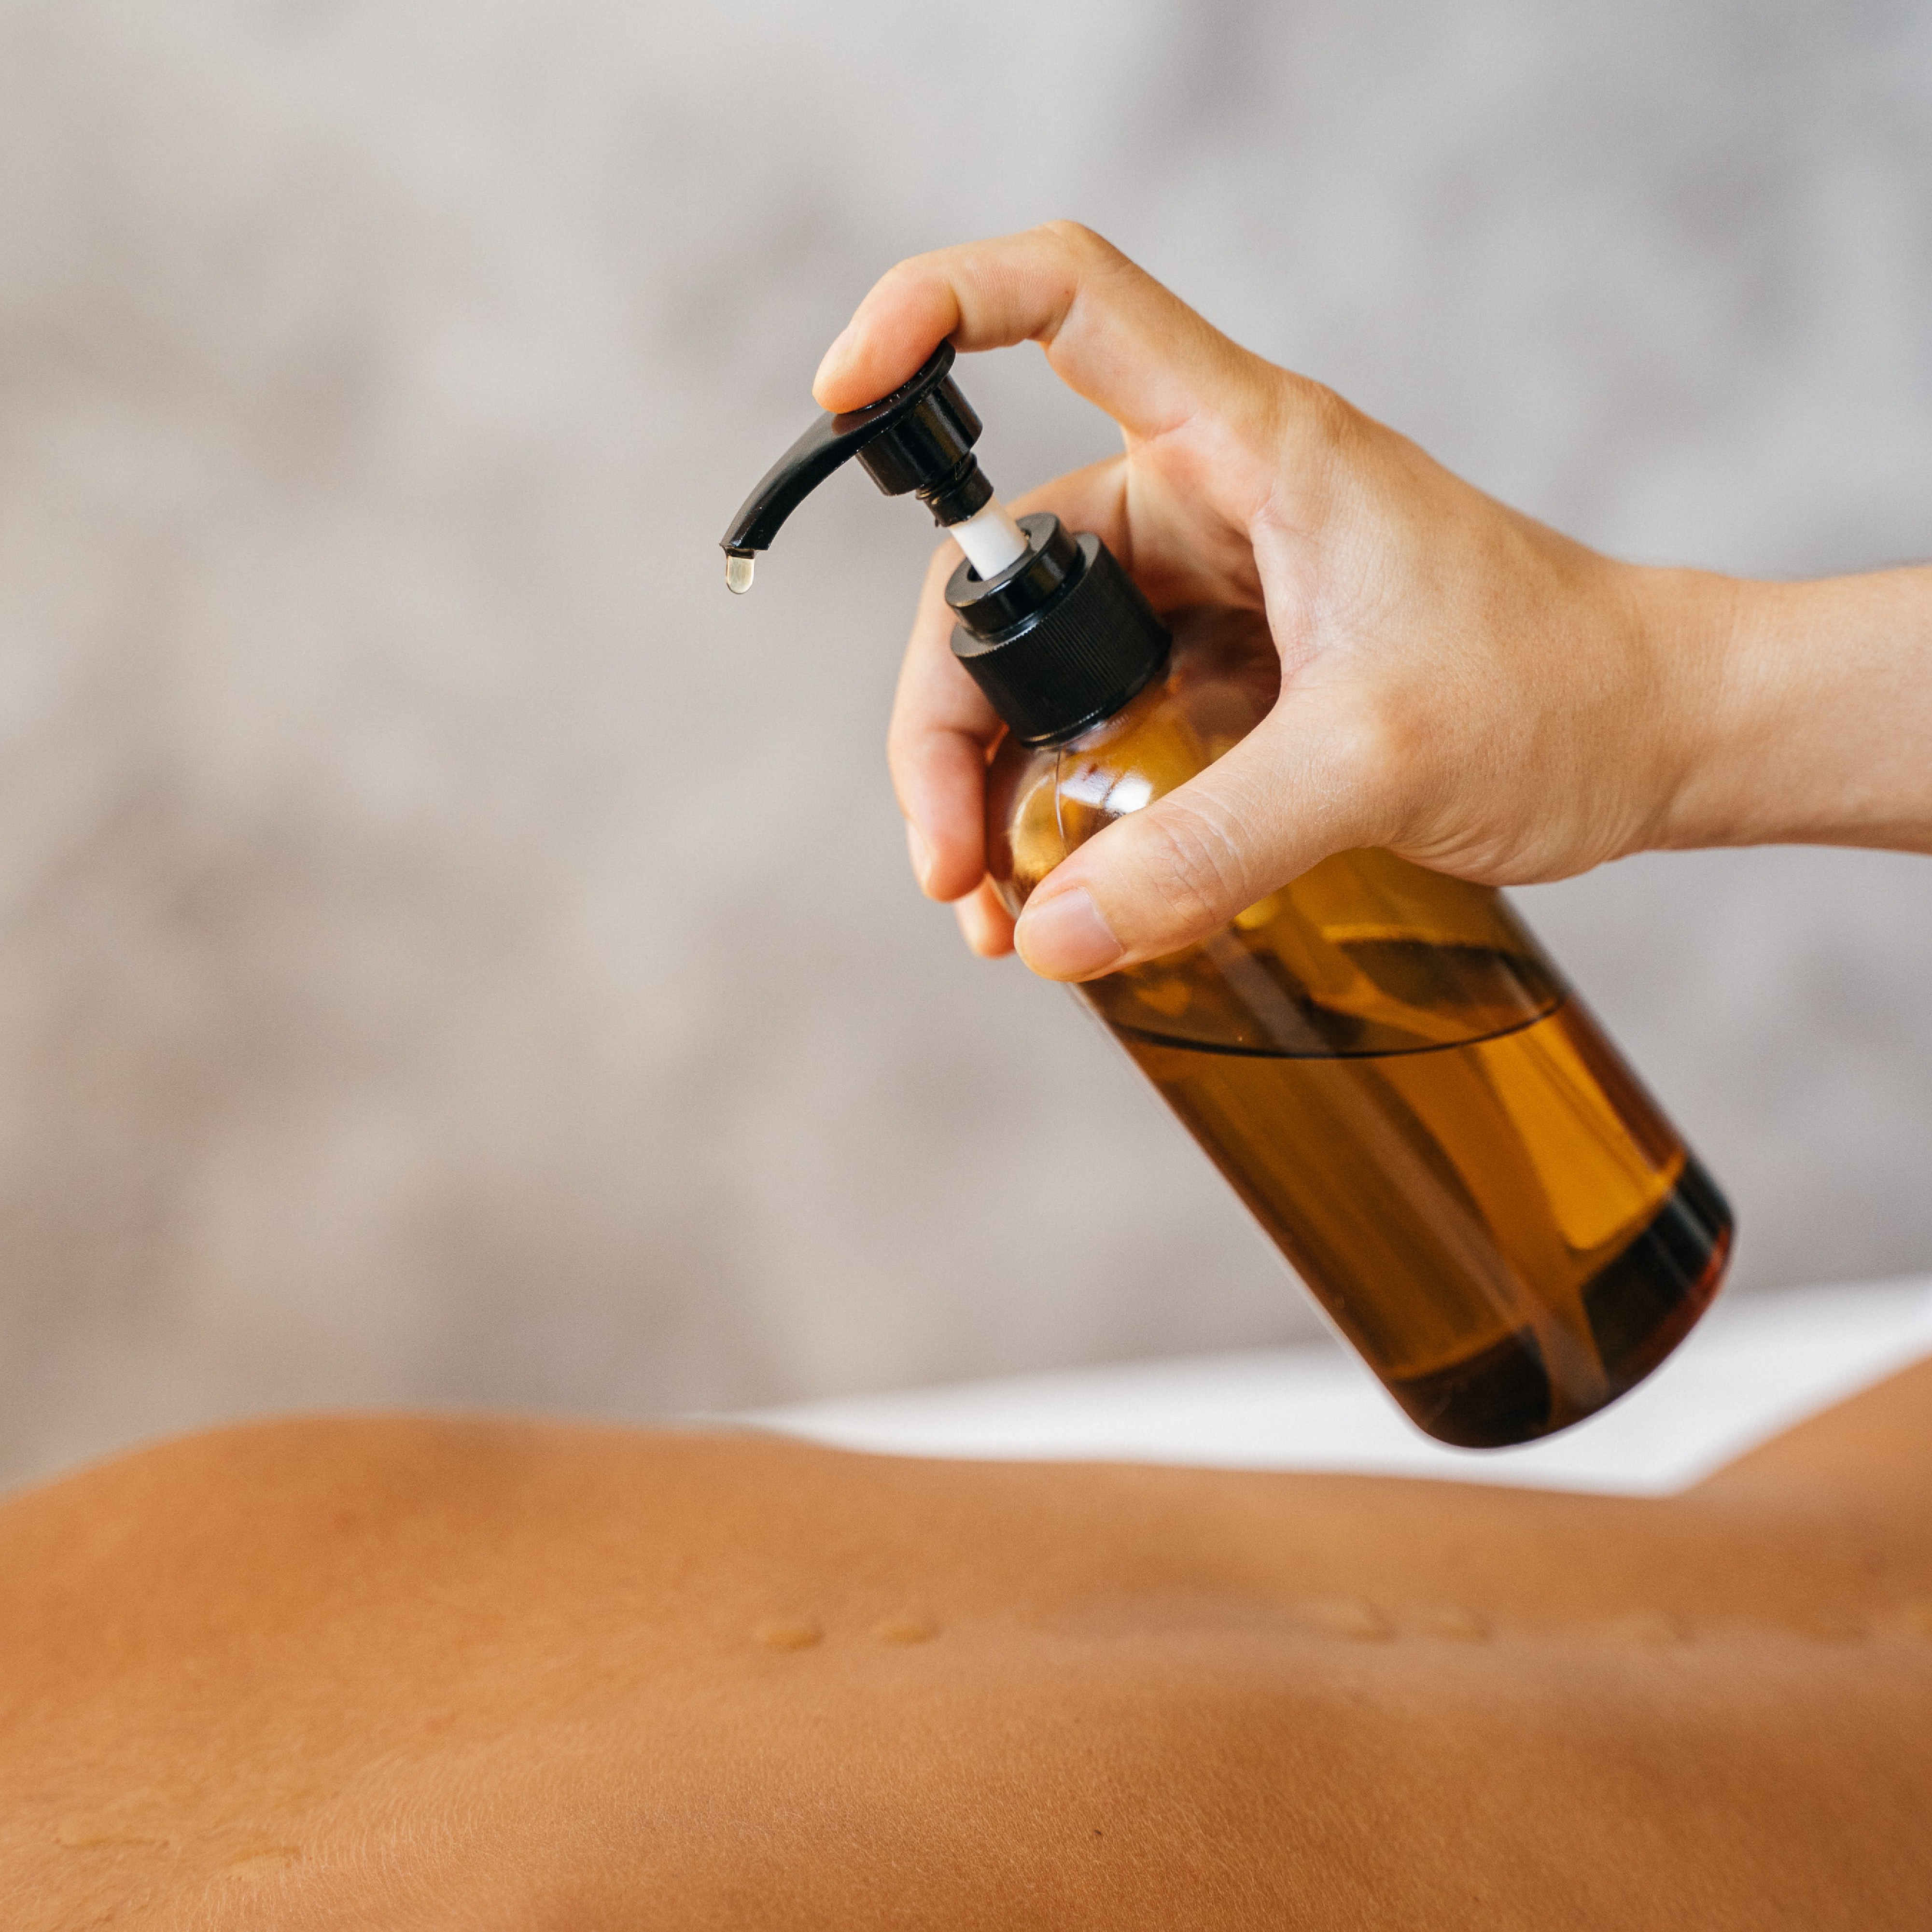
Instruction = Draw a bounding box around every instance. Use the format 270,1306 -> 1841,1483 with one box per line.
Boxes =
987,616 -> 1731,1447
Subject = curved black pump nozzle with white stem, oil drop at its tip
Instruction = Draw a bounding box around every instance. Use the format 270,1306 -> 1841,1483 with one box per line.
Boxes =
723,342 -> 1026,591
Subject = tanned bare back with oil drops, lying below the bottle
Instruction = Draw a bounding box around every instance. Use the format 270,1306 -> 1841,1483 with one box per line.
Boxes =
0,1364 -> 1932,1932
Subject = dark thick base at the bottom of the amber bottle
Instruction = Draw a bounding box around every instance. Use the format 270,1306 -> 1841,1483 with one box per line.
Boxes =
1389,1155 -> 1731,1449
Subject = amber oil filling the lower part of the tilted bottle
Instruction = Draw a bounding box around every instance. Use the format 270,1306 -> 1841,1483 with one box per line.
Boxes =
1090,941 -> 1729,1447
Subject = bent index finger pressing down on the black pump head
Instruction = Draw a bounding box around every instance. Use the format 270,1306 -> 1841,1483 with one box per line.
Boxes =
813,222 -> 1265,438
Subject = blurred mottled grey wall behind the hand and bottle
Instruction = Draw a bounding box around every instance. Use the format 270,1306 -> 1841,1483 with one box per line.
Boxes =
0,0 -> 1932,1476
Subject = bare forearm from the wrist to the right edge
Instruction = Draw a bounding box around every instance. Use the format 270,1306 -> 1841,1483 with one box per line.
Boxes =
1638,566 -> 1932,852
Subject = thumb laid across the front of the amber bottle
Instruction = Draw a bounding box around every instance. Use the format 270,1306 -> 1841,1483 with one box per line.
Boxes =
1014,692 -> 1387,980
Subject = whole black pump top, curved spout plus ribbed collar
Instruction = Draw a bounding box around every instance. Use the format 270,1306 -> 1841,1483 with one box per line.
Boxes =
723,342 -> 1171,744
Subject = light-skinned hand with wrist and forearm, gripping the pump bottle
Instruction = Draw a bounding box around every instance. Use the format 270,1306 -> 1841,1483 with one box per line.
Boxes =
815,222 -> 1932,980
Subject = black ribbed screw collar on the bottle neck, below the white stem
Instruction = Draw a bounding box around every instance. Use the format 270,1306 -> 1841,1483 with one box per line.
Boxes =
947,510 -> 1173,744
